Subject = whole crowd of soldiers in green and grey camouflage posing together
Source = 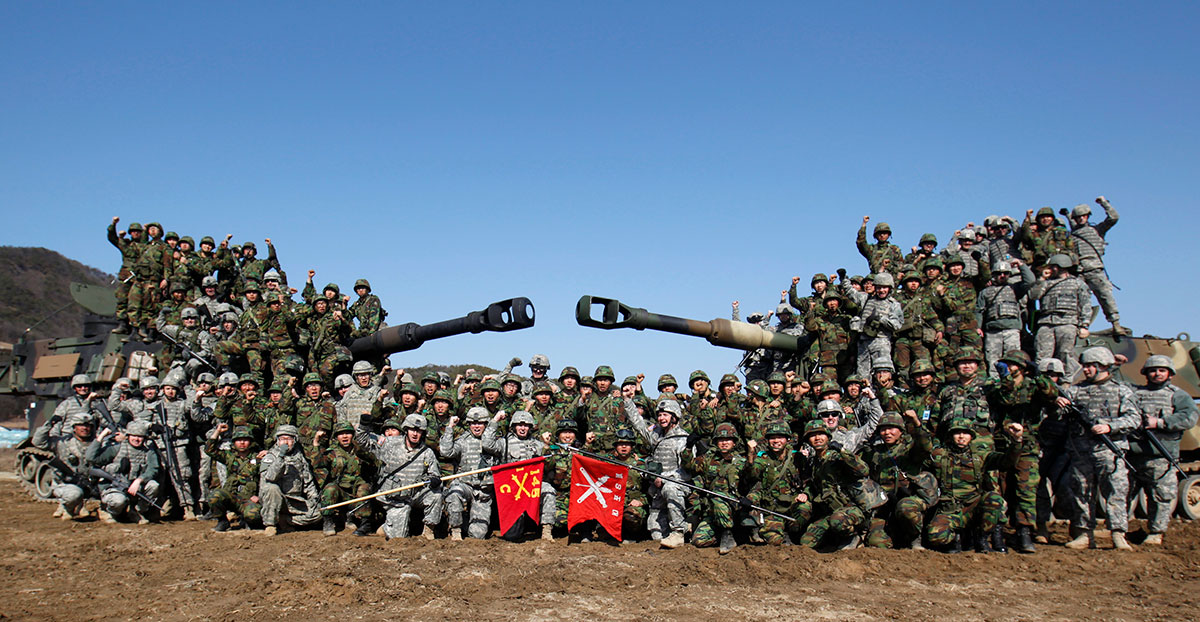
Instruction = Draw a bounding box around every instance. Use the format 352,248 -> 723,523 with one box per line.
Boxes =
34,207 -> 1198,552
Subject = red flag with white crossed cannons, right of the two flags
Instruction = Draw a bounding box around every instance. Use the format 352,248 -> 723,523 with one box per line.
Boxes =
566,454 -> 629,540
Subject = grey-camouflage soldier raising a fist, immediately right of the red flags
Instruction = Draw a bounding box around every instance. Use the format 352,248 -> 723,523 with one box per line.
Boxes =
624,400 -> 690,549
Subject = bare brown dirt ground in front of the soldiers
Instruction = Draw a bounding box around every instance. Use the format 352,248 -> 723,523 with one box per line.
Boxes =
0,473 -> 1200,621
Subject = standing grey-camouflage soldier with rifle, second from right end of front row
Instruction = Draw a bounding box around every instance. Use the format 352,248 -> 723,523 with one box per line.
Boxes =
1058,346 -> 1141,551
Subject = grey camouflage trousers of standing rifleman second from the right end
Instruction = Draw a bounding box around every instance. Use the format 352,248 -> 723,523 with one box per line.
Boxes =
1068,438 -> 1129,531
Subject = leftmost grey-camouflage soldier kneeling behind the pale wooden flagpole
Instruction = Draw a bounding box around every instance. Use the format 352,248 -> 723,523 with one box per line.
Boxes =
355,414 -> 443,540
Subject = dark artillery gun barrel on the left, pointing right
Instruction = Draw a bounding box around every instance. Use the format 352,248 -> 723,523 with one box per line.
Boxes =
350,298 -> 534,358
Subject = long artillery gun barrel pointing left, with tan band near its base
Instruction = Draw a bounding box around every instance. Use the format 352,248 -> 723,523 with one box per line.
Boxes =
575,295 -> 800,352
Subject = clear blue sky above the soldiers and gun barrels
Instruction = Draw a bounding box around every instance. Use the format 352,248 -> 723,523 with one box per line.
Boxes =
0,1 -> 1200,379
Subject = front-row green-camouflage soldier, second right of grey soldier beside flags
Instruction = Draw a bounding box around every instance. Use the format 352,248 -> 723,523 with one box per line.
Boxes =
746,423 -> 812,545
